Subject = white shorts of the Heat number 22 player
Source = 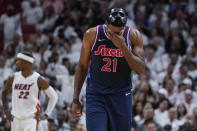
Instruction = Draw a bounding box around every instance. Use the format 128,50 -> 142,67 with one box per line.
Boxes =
11,118 -> 38,131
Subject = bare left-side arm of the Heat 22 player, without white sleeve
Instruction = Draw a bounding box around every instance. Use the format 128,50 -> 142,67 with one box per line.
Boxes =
2,76 -> 14,110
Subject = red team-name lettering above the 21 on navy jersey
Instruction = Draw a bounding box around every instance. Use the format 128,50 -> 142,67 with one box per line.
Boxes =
94,45 -> 124,57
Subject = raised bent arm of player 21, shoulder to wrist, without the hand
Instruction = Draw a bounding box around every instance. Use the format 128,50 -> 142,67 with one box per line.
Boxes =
121,30 -> 145,74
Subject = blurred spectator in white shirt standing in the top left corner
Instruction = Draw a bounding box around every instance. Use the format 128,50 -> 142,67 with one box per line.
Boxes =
0,4 -> 22,49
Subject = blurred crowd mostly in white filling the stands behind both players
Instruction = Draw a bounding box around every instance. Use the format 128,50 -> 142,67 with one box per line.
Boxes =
0,0 -> 197,131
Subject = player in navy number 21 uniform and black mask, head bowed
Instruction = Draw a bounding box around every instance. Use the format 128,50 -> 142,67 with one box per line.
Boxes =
72,8 -> 145,131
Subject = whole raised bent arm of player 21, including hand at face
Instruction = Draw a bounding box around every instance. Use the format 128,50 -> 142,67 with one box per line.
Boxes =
107,28 -> 145,74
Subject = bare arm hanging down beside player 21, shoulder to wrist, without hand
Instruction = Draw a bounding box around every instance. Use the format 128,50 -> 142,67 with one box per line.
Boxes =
73,28 -> 96,100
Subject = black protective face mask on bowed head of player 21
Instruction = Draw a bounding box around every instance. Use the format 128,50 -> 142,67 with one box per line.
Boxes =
107,8 -> 127,27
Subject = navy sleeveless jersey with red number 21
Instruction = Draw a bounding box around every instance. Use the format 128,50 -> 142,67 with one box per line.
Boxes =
87,25 -> 132,94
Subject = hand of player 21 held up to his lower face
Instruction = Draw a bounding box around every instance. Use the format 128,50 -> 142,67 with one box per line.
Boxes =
107,28 -> 125,48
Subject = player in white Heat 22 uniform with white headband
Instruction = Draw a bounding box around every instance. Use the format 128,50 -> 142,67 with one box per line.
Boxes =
2,52 -> 58,131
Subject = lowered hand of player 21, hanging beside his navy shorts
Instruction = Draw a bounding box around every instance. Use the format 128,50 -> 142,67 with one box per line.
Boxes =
71,103 -> 82,120
